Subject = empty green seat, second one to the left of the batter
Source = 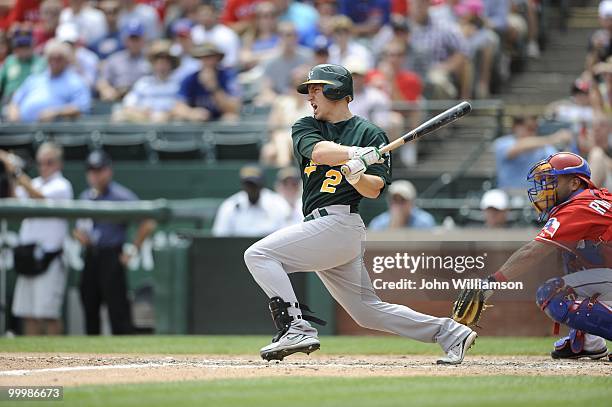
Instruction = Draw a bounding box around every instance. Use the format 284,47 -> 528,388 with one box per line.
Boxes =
151,124 -> 204,161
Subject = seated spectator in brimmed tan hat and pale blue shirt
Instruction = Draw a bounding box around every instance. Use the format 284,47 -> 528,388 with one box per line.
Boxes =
112,40 -> 179,123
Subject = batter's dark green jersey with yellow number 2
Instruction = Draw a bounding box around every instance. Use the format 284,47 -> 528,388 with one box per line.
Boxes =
291,116 -> 391,215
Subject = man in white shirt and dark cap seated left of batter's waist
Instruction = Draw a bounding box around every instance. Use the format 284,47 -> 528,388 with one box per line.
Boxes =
212,166 -> 291,236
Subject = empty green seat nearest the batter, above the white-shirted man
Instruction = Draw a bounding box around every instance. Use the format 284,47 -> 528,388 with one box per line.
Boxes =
205,122 -> 267,161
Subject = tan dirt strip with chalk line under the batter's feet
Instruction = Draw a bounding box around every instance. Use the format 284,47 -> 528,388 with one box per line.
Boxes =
0,353 -> 612,386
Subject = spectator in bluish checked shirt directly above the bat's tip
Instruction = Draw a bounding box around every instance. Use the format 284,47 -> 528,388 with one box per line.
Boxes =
410,0 -> 473,99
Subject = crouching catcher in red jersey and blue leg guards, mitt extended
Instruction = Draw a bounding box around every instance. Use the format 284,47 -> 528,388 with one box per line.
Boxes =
453,152 -> 612,360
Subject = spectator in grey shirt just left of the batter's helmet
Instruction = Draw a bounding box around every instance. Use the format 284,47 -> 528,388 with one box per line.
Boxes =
258,22 -> 312,104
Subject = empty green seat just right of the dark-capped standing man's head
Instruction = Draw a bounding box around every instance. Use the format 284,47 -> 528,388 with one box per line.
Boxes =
94,124 -> 155,161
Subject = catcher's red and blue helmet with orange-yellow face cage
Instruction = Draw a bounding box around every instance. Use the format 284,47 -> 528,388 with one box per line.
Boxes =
527,152 -> 595,221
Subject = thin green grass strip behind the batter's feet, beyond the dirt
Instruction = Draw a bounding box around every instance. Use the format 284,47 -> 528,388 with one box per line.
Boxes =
0,335 -> 596,355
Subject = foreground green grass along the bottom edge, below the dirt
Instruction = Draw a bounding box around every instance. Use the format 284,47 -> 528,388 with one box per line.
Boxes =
7,376 -> 612,407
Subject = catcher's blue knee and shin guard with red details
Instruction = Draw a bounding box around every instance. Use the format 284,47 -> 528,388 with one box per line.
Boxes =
536,277 -> 612,340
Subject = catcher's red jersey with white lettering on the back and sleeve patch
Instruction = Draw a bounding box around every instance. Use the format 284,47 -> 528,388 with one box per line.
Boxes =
535,189 -> 612,273
